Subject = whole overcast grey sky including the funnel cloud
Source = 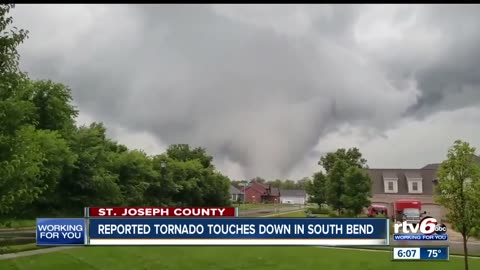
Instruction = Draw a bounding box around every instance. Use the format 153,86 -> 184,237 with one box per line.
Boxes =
13,5 -> 480,179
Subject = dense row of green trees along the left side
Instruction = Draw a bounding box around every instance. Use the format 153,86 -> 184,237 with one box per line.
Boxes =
0,5 -> 230,218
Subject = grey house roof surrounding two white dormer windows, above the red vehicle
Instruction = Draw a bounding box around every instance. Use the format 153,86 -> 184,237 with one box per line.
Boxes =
366,169 -> 437,195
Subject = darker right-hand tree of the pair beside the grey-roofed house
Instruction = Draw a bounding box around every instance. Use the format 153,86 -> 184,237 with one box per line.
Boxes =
340,166 -> 372,216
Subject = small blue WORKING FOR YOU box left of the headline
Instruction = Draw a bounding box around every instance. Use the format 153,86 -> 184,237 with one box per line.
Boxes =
36,218 -> 87,246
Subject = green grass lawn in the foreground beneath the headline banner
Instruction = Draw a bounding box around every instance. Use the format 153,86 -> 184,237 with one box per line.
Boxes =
0,247 -> 474,270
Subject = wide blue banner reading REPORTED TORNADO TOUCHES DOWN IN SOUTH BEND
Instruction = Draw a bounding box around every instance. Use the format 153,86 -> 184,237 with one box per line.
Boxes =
88,218 -> 389,246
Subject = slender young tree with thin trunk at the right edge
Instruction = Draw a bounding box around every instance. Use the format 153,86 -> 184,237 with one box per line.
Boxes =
436,140 -> 480,270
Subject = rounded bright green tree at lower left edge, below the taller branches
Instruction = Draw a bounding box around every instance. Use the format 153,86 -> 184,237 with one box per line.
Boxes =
0,126 -> 74,214
